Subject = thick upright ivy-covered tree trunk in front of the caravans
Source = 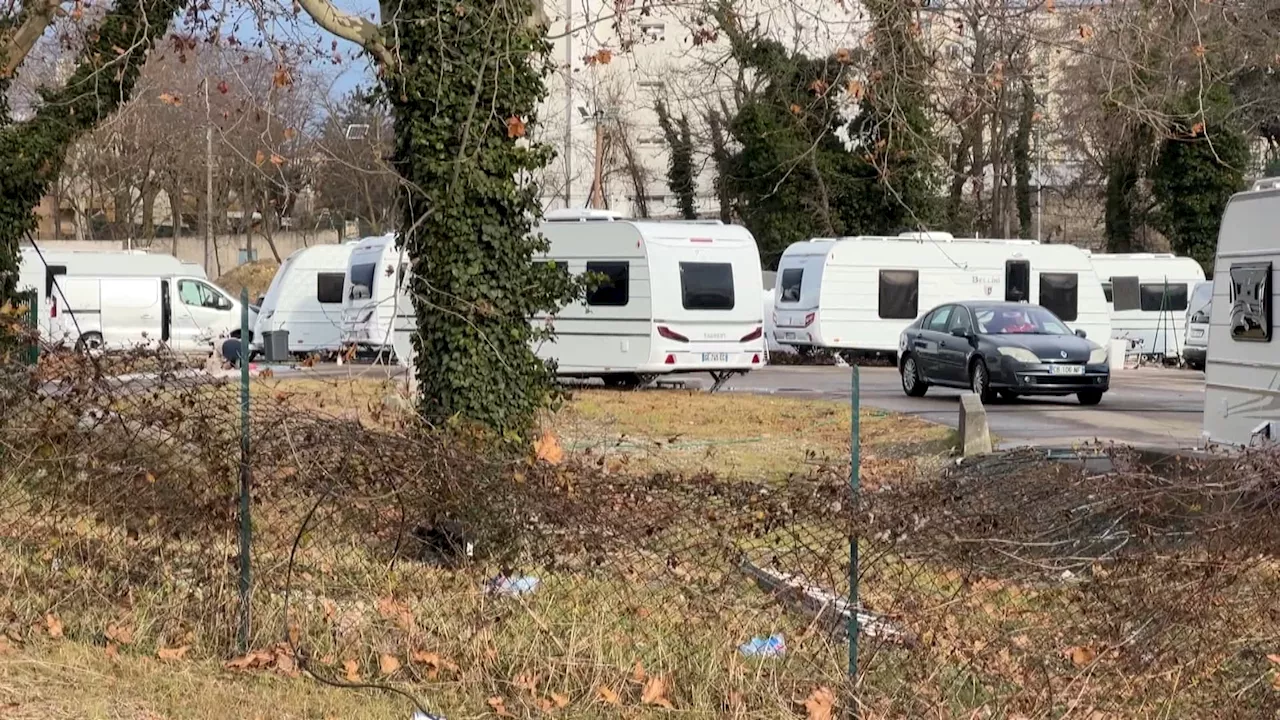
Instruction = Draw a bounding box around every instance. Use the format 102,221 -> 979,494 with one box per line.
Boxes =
384,0 -> 572,437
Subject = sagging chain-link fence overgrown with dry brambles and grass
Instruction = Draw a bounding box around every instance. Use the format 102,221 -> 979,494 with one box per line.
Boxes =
0,320 -> 1280,719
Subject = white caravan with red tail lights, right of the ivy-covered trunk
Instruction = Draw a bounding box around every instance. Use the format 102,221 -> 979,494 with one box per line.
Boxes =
535,209 -> 764,386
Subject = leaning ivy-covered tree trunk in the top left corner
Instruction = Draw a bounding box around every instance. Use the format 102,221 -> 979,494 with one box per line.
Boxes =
0,0 -> 182,304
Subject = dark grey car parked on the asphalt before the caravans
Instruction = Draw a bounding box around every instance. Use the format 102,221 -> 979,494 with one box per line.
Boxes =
897,301 -> 1111,405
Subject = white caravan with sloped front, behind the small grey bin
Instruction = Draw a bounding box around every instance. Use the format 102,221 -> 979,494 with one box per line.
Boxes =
253,241 -> 358,352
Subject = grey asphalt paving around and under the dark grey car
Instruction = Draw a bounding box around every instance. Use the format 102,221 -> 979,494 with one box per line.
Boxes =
727,366 -> 1204,447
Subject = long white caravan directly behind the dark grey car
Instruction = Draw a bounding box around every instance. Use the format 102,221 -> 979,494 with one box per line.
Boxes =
773,232 -> 1111,355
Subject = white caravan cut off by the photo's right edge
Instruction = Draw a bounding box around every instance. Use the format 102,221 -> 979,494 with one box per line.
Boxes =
1204,178 -> 1280,446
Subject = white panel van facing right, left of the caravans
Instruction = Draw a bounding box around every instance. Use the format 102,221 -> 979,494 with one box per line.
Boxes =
50,275 -> 253,352
